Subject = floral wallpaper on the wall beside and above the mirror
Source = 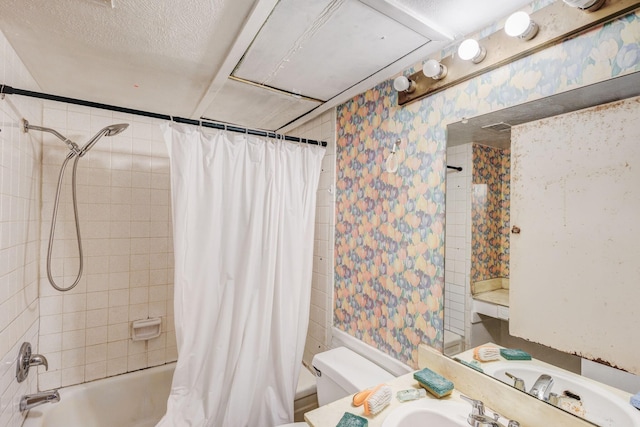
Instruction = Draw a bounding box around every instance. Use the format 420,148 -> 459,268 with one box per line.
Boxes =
334,12 -> 640,367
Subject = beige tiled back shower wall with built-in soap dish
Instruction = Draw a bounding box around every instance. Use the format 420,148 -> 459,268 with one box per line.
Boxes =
36,102 -> 177,390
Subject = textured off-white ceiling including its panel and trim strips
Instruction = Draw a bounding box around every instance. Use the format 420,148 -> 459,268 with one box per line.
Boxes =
0,0 -> 526,130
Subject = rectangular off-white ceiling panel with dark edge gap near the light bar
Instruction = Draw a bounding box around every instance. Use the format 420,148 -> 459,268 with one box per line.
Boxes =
234,0 -> 429,100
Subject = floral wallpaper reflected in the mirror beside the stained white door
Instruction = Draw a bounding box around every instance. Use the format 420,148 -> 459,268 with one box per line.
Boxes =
471,144 -> 511,282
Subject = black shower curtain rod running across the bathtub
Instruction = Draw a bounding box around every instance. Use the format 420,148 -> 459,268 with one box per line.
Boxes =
0,84 -> 327,147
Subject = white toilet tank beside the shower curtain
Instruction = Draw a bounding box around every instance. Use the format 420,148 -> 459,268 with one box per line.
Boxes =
311,347 -> 395,406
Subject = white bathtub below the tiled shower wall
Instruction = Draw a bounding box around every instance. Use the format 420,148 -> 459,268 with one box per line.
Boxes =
23,363 -> 175,427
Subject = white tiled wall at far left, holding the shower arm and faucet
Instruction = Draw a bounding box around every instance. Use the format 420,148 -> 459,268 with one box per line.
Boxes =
0,32 -> 44,427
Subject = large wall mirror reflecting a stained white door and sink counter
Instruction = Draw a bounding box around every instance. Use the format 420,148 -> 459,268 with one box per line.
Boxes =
444,73 -> 640,426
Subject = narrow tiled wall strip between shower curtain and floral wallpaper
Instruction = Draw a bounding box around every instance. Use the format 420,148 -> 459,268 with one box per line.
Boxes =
289,109 -> 336,365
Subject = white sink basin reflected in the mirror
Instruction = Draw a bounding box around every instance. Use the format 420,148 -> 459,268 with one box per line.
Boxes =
482,361 -> 640,427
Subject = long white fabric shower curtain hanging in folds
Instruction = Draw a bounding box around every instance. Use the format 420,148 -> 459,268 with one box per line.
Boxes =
157,123 -> 325,427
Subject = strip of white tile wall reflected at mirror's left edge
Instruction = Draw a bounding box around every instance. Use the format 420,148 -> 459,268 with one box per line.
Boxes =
444,144 -> 473,339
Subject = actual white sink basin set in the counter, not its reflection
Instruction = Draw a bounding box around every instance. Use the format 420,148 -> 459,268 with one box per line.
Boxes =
382,398 -> 471,427
